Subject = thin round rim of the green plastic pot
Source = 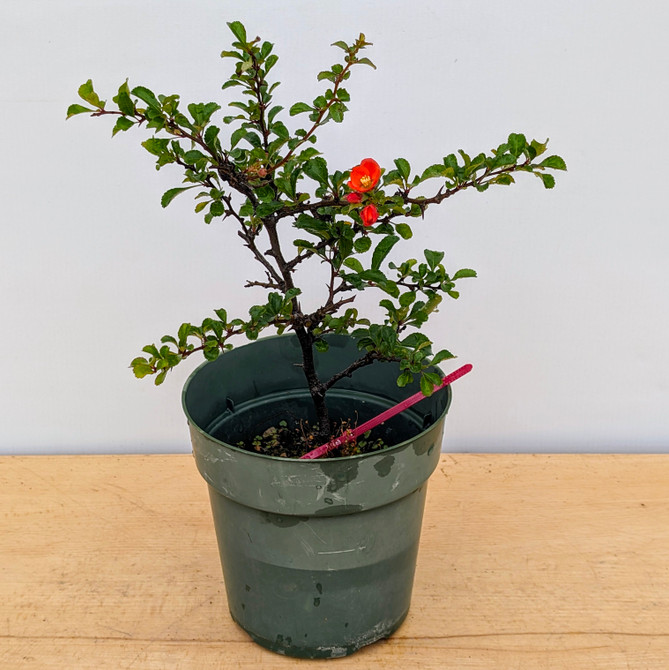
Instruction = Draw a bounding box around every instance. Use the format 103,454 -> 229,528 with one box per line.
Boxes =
181,335 -> 453,466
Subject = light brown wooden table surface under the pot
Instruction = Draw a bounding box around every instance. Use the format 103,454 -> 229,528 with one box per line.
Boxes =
0,454 -> 669,670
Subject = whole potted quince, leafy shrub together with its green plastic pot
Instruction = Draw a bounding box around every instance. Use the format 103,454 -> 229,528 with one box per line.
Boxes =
67,22 -> 566,658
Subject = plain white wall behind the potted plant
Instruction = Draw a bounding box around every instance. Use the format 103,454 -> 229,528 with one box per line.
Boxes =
0,0 -> 669,453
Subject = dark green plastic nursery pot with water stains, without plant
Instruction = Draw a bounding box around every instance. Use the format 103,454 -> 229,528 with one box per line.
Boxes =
183,336 -> 451,658
